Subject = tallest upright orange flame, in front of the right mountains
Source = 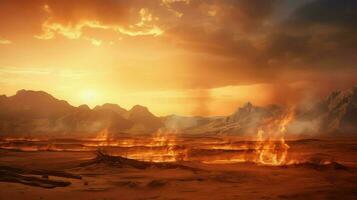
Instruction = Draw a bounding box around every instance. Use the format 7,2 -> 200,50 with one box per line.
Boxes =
255,110 -> 294,166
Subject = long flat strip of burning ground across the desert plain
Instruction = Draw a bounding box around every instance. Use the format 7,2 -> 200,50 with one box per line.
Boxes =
0,136 -> 353,168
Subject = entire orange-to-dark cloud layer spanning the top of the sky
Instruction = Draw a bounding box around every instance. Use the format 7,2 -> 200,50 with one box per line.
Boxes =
0,0 -> 357,94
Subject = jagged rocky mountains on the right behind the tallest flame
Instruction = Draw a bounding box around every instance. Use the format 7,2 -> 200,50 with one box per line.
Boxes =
165,87 -> 357,136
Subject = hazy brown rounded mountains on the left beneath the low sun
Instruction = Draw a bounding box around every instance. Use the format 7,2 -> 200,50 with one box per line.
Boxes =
0,90 -> 163,137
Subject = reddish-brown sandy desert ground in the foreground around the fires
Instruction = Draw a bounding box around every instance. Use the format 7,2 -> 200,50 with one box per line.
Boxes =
0,140 -> 357,200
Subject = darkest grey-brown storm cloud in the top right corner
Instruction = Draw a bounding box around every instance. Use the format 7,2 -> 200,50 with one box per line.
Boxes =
264,0 -> 357,70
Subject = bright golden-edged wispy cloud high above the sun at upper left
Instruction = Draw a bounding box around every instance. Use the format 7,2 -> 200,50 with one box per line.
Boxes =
35,1 -> 163,46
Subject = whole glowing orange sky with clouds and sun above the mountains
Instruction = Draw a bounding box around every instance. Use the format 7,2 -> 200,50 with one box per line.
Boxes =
0,0 -> 357,116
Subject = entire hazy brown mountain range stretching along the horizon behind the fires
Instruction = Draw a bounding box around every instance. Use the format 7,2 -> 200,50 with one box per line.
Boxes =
0,87 -> 357,137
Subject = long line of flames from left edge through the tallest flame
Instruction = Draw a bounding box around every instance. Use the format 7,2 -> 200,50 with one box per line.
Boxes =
0,109 -> 294,166
